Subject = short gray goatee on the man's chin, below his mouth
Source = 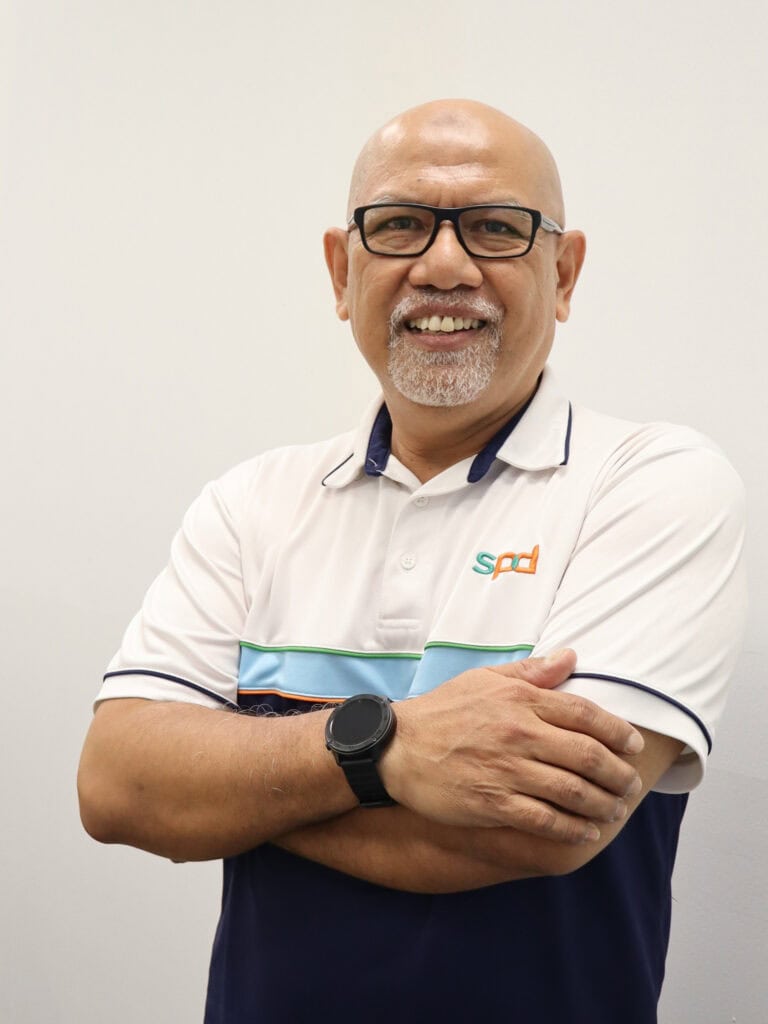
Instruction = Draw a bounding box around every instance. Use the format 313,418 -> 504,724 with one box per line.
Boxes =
387,299 -> 502,407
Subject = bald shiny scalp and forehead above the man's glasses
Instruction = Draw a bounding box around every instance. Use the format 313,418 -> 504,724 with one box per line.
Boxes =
349,99 -> 564,226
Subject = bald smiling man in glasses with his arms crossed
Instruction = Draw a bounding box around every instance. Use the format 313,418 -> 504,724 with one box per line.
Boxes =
80,101 -> 743,1024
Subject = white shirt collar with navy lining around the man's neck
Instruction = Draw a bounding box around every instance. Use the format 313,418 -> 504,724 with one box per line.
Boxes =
323,367 -> 572,488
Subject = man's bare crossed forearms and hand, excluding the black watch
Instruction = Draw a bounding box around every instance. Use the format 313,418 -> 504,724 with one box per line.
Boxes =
78,651 -> 682,892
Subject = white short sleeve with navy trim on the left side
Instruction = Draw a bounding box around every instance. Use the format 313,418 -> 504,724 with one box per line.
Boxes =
97,477 -> 246,708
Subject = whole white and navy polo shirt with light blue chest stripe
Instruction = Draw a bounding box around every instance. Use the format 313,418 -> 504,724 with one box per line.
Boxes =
98,369 -> 744,1024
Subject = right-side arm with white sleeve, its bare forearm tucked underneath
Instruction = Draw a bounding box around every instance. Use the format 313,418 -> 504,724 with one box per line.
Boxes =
279,436 -> 743,892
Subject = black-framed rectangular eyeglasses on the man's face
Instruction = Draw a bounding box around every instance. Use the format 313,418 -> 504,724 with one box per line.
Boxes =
347,203 -> 563,259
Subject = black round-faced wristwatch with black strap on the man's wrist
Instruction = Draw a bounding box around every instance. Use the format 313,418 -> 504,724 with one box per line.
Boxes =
326,693 -> 396,807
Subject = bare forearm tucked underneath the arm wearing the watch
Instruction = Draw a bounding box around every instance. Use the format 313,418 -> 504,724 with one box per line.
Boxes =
274,730 -> 682,893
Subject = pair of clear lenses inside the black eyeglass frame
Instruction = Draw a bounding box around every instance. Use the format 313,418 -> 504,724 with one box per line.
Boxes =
362,206 -> 534,256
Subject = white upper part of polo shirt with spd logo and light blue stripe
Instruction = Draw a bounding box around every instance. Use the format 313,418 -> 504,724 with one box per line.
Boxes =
98,370 -> 745,793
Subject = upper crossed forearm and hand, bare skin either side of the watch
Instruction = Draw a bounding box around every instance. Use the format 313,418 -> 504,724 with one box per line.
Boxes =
79,651 -> 640,860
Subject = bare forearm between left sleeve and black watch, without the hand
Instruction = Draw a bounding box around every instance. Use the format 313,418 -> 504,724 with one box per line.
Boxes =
78,699 -> 355,860
